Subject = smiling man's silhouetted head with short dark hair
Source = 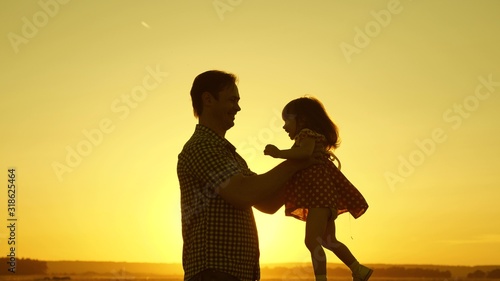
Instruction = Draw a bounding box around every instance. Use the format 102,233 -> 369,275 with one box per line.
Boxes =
191,70 -> 241,136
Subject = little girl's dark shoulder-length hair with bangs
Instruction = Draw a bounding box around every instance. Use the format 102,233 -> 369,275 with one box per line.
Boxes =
282,97 -> 340,150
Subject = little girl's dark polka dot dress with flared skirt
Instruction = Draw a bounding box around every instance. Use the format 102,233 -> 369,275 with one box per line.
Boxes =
285,129 -> 368,221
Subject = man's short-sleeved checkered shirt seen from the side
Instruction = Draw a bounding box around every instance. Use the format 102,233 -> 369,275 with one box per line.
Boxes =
177,124 -> 260,281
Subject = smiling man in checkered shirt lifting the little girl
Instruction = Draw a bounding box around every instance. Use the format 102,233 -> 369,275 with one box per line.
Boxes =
177,70 -> 312,281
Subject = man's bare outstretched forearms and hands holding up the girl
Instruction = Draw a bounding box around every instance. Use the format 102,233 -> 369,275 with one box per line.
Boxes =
218,160 -> 304,209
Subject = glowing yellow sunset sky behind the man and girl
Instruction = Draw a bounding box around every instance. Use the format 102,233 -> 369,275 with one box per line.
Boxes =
0,0 -> 500,265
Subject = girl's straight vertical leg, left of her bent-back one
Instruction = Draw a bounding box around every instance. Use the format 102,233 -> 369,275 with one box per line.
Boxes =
304,208 -> 331,280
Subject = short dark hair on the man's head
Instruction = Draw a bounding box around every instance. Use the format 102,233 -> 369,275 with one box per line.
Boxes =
191,70 -> 238,118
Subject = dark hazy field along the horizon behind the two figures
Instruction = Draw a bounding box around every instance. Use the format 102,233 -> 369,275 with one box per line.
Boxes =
0,261 -> 500,281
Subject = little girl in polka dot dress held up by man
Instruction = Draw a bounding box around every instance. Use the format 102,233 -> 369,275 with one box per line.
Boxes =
264,97 -> 373,281
